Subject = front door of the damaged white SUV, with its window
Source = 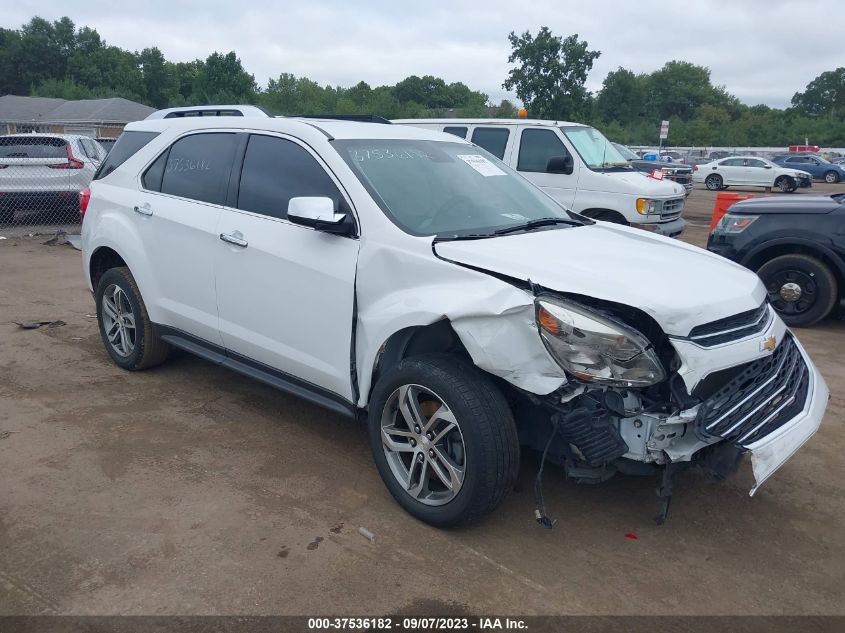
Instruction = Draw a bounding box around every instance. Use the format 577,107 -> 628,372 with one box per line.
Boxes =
214,134 -> 359,401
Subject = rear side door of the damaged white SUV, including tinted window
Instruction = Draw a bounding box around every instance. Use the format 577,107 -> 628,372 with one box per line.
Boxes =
132,132 -> 239,345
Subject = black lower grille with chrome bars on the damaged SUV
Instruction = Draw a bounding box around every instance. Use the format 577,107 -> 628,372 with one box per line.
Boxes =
696,333 -> 810,448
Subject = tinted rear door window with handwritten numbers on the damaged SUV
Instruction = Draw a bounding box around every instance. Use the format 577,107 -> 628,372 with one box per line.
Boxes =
160,132 -> 235,204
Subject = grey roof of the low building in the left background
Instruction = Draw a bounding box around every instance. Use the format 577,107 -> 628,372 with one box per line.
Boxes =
0,95 -> 155,123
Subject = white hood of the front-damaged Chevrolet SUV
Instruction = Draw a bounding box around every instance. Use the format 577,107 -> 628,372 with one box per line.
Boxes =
434,222 -> 766,336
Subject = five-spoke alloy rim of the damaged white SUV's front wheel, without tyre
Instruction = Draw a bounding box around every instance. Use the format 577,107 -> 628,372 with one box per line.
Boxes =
381,385 -> 466,506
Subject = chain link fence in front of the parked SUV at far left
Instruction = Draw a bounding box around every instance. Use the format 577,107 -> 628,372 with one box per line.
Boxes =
0,123 -> 123,237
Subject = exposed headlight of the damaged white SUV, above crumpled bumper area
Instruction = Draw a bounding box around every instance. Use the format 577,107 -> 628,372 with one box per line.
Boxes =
535,297 -> 666,387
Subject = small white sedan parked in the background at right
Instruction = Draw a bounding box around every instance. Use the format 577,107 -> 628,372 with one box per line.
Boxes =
692,156 -> 813,193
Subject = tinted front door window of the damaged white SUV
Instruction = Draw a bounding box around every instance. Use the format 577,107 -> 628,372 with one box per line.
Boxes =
238,135 -> 342,218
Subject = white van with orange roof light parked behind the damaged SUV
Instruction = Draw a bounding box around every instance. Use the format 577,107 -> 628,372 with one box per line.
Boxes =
393,119 -> 686,237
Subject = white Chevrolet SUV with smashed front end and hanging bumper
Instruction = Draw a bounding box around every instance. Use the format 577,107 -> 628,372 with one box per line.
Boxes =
82,117 -> 828,526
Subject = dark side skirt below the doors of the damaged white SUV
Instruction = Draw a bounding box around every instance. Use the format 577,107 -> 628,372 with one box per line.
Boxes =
153,323 -> 358,418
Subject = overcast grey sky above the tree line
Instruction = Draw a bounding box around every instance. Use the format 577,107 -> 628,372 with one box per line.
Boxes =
0,0 -> 845,107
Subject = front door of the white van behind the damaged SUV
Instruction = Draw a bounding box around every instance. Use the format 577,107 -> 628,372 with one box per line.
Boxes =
515,127 -> 578,209
